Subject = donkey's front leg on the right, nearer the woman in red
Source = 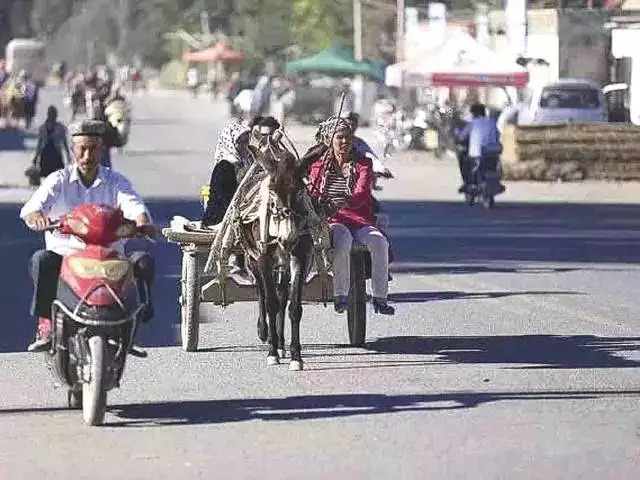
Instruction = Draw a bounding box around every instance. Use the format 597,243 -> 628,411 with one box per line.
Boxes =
289,235 -> 312,371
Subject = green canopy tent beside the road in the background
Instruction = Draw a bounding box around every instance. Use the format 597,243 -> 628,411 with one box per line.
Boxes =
285,45 -> 384,82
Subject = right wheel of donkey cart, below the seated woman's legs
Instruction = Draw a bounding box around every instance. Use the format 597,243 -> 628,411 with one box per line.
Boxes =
347,251 -> 367,347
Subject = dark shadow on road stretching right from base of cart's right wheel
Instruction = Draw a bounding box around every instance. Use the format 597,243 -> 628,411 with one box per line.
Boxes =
365,335 -> 640,369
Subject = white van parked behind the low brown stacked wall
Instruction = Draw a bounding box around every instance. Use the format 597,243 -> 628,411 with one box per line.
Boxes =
517,78 -> 608,125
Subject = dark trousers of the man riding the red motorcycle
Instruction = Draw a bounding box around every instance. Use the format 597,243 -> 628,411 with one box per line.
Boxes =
29,250 -> 155,318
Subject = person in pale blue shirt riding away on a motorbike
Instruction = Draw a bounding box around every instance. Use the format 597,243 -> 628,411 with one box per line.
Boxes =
456,103 -> 504,193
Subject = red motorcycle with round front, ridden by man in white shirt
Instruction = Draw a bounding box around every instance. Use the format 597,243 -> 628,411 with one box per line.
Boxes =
46,205 -> 150,425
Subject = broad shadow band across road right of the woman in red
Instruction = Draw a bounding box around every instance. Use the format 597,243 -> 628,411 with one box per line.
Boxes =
382,201 -> 640,266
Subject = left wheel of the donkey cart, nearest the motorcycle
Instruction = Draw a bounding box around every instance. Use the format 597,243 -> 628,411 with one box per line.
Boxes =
180,251 -> 200,352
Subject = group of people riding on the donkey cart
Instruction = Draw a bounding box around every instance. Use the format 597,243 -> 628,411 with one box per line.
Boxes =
201,114 -> 394,315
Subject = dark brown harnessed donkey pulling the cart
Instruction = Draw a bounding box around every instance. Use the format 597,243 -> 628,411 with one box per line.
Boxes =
239,128 -> 318,371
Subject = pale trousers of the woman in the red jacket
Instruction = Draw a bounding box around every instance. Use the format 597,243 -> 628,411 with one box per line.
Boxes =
331,223 -> 389,300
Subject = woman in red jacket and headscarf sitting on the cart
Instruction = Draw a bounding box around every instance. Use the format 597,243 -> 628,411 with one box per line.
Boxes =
308,117 -> 395,315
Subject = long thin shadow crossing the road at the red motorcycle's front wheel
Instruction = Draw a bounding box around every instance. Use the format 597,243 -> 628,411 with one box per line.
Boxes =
0,389 -> 640,428
